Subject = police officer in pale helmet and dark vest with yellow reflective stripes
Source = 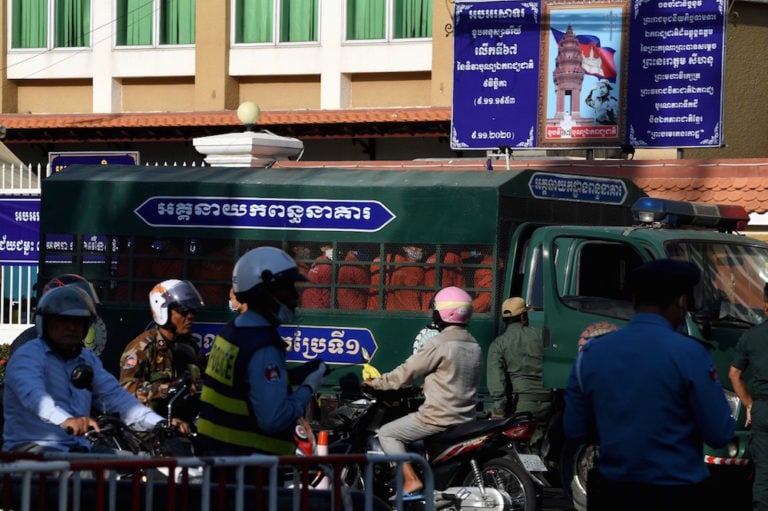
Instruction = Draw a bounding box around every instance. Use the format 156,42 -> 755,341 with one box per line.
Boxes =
197,246 -> 326,455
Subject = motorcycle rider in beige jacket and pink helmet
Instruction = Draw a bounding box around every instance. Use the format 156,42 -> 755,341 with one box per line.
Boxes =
364,287 -> 483,500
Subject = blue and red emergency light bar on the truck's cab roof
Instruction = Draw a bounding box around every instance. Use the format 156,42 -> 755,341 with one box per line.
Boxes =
632,197 -> 749,232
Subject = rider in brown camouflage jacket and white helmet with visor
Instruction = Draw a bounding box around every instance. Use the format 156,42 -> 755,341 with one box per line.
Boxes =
120,279 -> 205,428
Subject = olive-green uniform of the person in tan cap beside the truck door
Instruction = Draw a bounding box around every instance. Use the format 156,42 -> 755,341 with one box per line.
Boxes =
486,323 -> 552,443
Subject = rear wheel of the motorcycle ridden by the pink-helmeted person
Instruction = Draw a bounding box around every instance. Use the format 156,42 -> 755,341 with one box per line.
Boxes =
464,458 -> 538,511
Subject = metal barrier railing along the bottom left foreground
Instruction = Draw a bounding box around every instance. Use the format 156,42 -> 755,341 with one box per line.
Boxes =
0,452 -> 434,511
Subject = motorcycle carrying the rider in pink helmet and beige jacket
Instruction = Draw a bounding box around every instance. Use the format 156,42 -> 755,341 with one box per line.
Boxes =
316,386 -> 543,511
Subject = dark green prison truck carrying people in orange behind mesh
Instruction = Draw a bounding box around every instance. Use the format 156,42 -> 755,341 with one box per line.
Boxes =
39,165 -> 768,504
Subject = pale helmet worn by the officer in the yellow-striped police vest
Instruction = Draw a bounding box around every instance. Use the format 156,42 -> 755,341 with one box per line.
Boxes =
232,247 -> 307,294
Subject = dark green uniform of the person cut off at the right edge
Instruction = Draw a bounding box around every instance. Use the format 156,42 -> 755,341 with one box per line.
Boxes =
731,322 -> 768,510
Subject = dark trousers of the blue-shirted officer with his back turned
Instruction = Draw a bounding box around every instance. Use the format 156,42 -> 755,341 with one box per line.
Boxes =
587,469 -> 722,511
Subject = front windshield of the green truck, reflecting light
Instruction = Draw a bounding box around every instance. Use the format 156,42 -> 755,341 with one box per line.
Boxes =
667,241 -> 768,326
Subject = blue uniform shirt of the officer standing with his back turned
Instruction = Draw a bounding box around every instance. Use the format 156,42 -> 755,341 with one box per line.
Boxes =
563,313 -> 735,485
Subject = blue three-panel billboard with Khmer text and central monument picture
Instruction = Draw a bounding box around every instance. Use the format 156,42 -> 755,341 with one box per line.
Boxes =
451,0 -> 726,150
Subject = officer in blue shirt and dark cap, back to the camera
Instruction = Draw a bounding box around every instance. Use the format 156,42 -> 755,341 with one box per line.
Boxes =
563,259 -> 735,511
